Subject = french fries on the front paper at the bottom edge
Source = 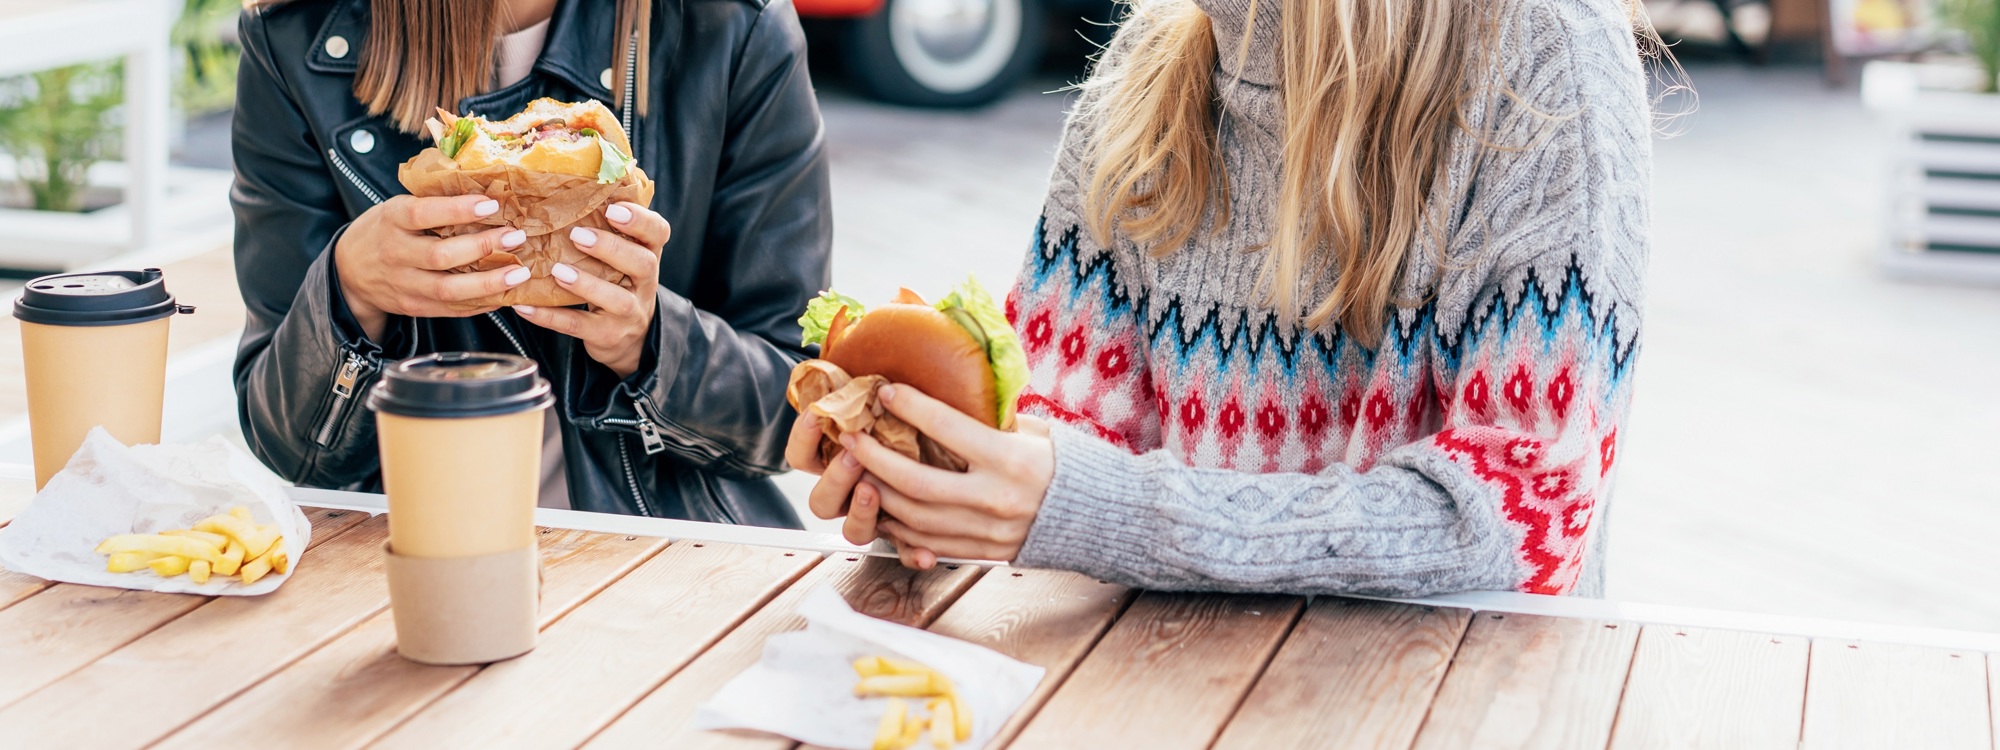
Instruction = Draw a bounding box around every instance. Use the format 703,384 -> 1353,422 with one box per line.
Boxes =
854,656 -> 972,750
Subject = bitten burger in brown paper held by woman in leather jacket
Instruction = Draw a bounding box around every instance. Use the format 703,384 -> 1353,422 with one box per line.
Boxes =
396,98 -> 652,310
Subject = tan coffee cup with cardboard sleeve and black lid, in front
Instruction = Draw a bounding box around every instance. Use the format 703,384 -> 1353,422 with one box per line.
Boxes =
368,352 -> 554,664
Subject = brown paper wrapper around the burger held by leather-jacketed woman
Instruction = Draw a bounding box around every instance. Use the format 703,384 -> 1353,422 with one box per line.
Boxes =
396,146 -> 652,310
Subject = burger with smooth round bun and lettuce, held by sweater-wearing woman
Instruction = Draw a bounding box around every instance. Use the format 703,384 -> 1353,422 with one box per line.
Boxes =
786,278 -> 1028,470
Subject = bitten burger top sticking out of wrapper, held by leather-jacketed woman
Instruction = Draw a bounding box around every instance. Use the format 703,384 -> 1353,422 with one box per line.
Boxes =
424,98 -> 632,184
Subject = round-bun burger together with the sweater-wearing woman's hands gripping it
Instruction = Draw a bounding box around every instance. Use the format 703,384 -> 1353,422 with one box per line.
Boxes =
786,282 -> 1054,568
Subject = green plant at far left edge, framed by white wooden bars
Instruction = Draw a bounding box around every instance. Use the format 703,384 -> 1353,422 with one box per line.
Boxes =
0,62 -> 124,212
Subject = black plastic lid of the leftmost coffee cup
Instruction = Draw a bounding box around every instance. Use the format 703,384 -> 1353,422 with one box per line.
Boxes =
14,268 -> 194,326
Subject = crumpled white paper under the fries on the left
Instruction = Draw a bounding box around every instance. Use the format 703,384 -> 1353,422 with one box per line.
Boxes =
0,428 -> 312,596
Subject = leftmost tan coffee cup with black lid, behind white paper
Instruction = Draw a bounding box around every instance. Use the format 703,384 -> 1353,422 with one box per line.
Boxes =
14,268 -> 194,490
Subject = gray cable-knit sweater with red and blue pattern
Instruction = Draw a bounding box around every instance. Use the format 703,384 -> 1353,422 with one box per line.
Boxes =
1010,0 -> 1652,596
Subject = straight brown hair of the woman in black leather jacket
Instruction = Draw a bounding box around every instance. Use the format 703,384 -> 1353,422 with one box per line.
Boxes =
246,0 -> 652,134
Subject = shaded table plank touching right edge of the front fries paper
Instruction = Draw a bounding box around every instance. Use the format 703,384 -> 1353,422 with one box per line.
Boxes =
930,570 -> 1136,750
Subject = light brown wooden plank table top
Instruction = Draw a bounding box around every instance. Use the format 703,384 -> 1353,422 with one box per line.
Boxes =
0,508 -> 2000,750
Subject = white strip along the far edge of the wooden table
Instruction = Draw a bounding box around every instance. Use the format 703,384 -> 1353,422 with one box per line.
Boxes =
290,488 -> 2000,652
